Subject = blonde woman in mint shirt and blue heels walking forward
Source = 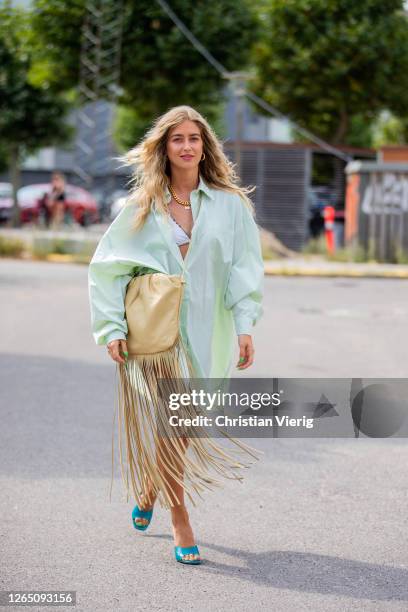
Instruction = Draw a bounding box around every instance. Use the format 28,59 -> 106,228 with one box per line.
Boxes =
89,106 -> 264,564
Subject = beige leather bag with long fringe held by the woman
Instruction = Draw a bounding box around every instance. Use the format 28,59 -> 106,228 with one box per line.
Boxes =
111,271 -> 259,508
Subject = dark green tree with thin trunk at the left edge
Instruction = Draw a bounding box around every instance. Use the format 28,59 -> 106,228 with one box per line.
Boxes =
0,8 -> 72,225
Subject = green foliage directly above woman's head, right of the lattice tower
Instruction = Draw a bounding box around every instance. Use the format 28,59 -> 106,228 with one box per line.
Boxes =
118,0 -> 257,118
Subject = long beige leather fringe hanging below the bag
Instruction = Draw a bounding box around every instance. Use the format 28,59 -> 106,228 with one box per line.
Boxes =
109,336 -> 263,509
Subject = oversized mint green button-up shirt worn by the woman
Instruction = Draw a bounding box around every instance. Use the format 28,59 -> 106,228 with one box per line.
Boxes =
88,175 -> 264,379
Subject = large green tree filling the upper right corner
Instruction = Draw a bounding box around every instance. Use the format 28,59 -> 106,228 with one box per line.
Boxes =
252,0 -> 408,145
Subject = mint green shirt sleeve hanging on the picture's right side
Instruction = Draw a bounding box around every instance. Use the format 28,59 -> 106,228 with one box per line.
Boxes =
224,196 -> 264,335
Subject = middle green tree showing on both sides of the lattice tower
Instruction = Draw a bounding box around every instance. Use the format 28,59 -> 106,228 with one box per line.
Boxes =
33,0 -> 257,141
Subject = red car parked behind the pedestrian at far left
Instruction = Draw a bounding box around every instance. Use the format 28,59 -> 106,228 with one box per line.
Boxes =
17,183 -> 99,226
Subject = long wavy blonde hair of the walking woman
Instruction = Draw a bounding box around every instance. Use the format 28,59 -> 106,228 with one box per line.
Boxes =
118,105 -> 256,230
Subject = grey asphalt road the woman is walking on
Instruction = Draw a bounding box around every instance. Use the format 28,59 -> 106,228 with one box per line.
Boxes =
0,259 -> 408,612
